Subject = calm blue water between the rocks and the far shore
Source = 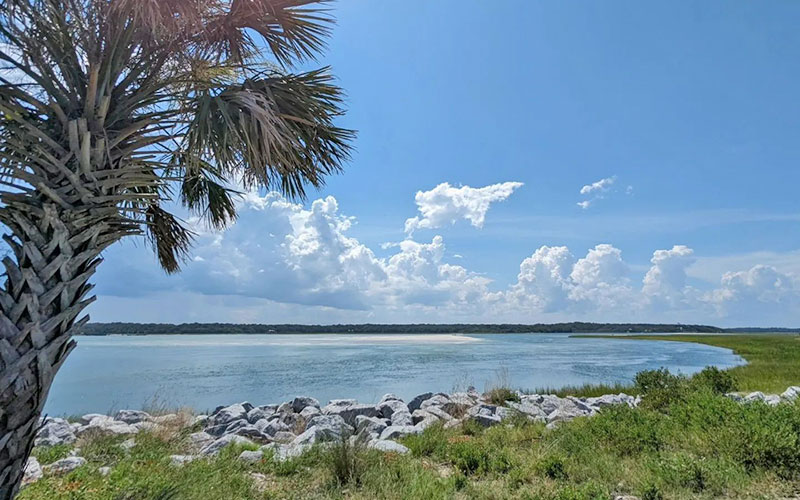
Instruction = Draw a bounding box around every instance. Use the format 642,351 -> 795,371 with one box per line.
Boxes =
46,334 -> 743,415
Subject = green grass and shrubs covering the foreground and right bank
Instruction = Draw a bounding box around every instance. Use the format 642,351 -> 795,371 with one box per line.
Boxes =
19,336 -> 800,500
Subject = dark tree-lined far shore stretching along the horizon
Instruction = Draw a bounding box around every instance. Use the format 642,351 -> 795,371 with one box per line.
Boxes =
76,322 -> 800,336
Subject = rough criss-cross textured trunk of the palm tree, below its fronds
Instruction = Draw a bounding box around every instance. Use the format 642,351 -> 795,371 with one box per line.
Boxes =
0,201 -> 124,500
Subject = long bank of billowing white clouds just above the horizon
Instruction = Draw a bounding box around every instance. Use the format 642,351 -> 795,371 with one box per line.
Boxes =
98,189 -> 800,324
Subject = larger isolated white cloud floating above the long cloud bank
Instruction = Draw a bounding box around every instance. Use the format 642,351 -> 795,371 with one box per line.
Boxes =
405,182 -> 522,234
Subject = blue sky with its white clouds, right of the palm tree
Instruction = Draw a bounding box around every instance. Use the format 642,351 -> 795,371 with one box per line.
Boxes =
90,0 -> 800,326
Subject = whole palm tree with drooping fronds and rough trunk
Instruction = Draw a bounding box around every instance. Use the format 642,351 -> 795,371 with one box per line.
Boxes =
0,0 -> 354,494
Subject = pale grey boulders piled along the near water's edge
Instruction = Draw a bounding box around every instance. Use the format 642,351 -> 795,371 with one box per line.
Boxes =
23,386 -> 800,485
